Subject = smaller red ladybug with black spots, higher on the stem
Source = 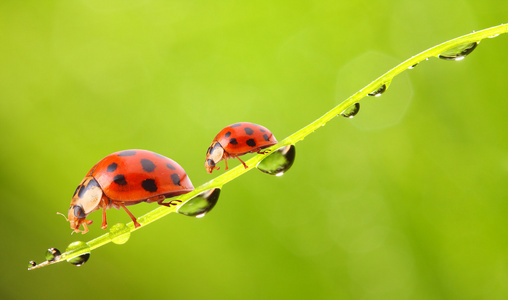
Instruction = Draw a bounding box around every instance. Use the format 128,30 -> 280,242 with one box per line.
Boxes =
205,122 -> 277,173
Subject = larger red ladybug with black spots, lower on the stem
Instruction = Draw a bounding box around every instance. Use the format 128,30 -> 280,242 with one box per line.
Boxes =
61,149 -> 194,234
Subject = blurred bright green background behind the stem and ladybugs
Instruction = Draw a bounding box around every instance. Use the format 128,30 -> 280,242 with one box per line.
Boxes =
0,0 -> 508,299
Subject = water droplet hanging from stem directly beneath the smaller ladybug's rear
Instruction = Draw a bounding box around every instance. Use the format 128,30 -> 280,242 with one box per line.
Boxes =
256,145 -> 296,176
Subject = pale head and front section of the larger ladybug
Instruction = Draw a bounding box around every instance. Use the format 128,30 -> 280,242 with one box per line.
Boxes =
67,176 -> 103,234
